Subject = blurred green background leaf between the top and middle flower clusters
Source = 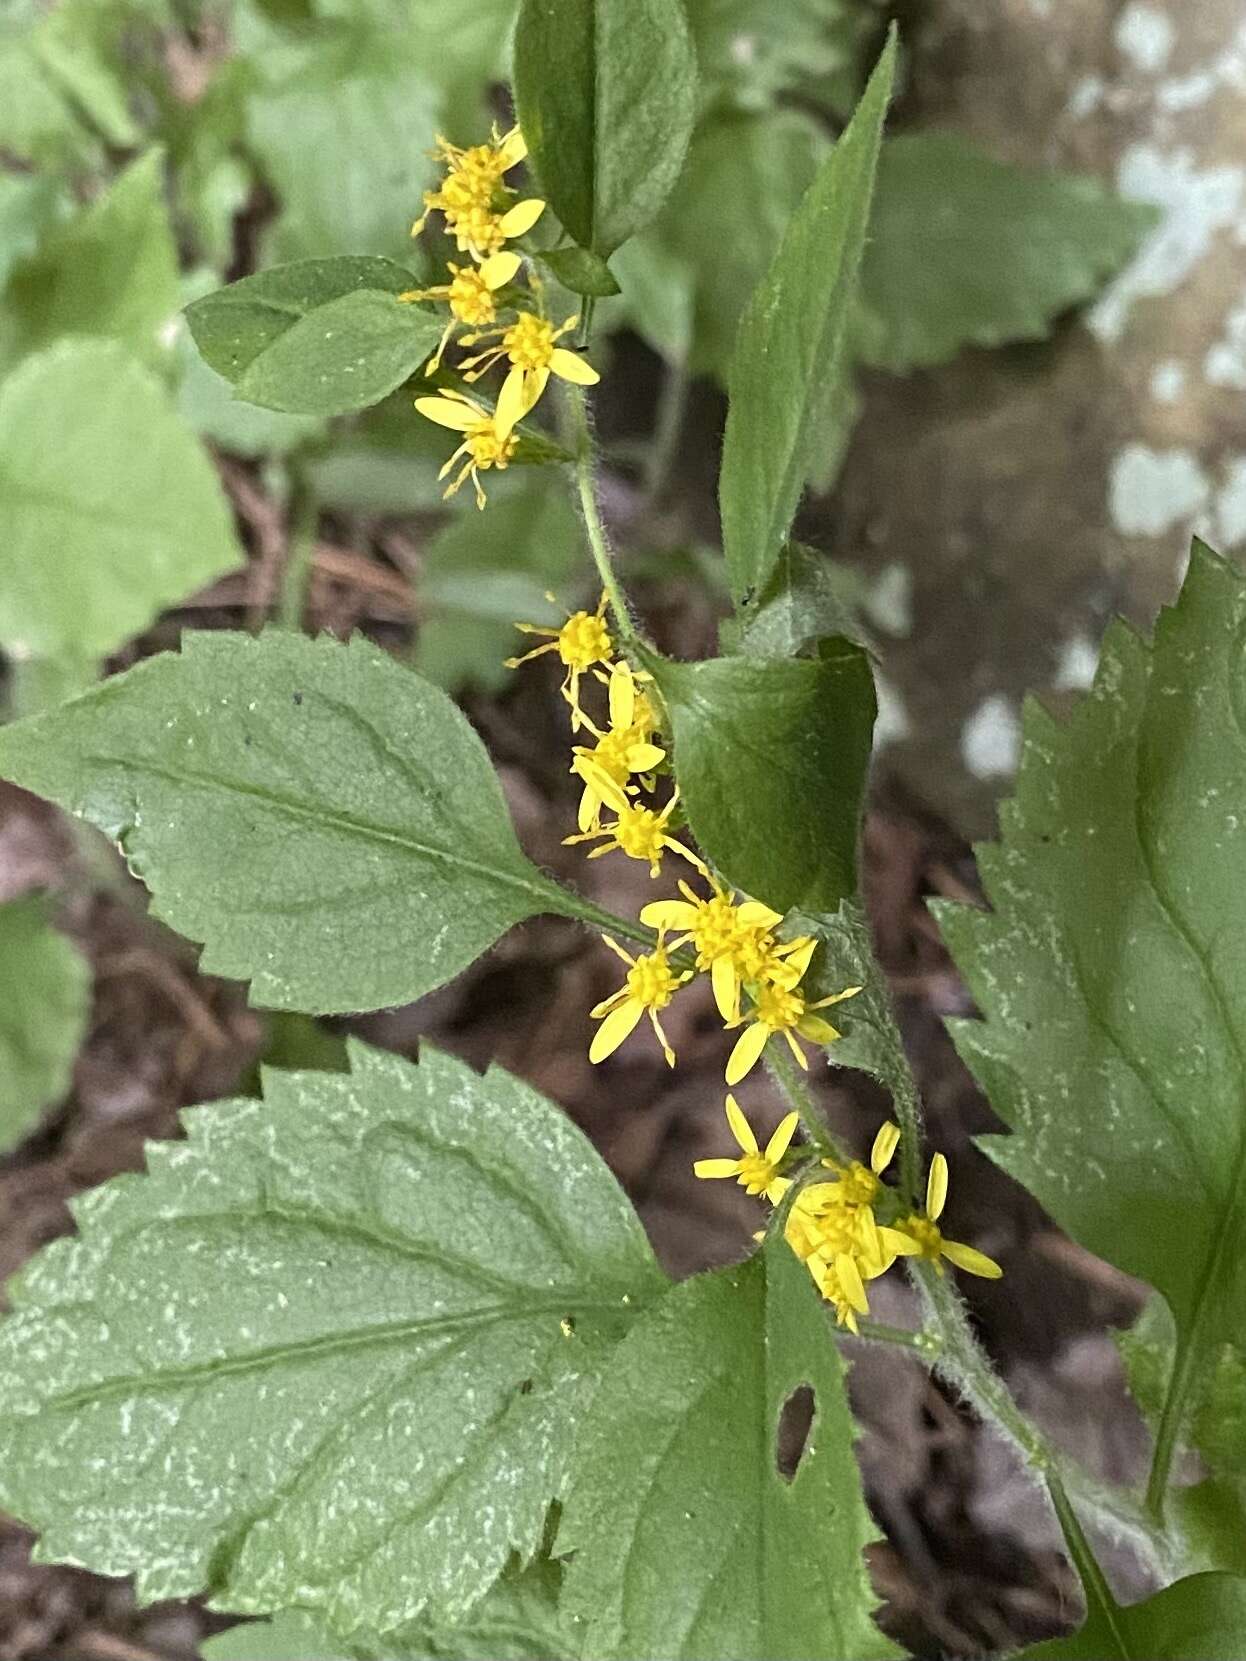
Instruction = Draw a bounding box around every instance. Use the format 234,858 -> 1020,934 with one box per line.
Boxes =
415,480 -> 581,689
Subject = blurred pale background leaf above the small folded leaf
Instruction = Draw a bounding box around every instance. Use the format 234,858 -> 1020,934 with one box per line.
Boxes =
248,28 -> 439,262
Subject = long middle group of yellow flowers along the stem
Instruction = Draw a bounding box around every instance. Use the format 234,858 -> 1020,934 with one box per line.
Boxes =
507,595 -> 861,1085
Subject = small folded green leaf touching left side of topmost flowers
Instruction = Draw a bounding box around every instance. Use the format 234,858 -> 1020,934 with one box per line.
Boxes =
186,257 -> 442,415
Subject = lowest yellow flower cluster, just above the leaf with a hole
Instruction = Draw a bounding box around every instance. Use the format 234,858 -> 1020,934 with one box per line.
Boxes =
693,1096 -> 1003,1332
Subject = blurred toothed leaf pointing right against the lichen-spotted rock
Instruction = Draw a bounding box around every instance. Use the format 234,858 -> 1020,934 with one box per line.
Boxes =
856,133 -> 1155,370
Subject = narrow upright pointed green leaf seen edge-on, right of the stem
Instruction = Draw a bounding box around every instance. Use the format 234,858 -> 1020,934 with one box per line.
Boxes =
719,30 -> 895,601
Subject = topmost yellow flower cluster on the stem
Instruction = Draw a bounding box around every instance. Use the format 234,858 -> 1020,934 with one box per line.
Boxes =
407,126 -> 598,507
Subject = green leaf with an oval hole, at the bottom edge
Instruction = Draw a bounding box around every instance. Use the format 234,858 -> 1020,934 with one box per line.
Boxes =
555,1241 -> 899,1661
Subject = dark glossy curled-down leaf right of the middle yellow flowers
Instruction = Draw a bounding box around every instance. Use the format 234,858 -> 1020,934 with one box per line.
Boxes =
648,639 -> 876,912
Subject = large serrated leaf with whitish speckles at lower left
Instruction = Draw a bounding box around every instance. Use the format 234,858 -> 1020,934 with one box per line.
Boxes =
0,1043 -> 665,1639
